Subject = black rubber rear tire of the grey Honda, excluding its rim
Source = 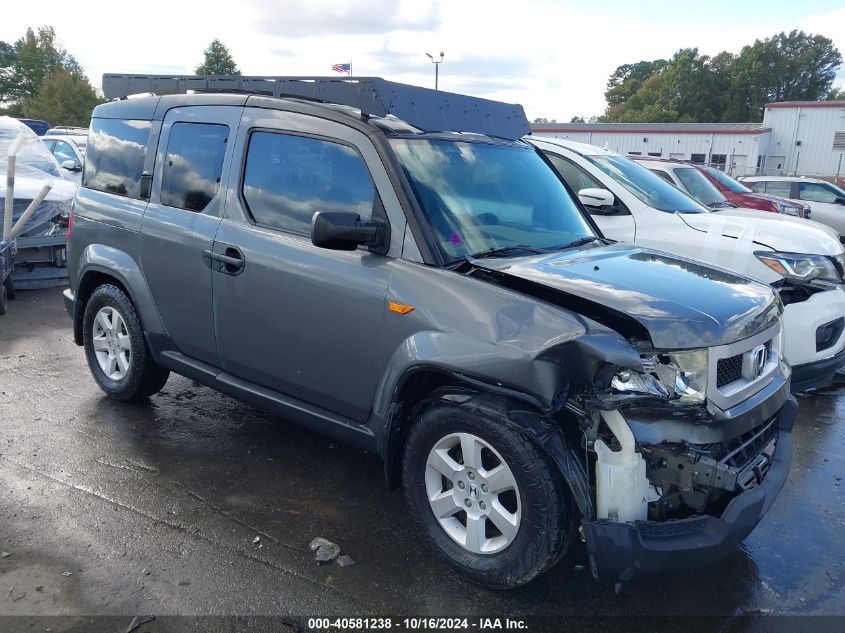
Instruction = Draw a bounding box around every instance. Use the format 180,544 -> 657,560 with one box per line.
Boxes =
82,284 -> 170,401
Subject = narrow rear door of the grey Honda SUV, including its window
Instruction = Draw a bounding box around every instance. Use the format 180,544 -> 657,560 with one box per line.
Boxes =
141,106 -> 243,365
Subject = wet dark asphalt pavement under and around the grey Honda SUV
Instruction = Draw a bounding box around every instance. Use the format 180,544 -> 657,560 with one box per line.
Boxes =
0,289 -> 845,631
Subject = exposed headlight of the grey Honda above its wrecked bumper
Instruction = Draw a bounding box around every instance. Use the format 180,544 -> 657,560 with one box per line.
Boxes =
610,349 -> 708,404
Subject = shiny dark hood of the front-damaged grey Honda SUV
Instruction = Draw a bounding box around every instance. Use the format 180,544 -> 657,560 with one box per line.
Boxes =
476,244 -> 780,350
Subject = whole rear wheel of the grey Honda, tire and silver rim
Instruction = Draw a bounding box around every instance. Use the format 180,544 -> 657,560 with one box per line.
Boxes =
82,285 -> 170,400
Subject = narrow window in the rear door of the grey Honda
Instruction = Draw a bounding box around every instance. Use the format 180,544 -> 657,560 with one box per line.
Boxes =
161,123 -> 229,211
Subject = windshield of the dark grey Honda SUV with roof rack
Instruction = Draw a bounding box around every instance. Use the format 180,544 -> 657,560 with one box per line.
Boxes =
390,138 -> 595,261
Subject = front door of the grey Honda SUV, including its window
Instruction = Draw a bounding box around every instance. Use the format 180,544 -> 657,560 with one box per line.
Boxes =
213,108 -> 391,422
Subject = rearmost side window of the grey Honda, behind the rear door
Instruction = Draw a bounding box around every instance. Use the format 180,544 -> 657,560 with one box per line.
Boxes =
82,119 -> 151,198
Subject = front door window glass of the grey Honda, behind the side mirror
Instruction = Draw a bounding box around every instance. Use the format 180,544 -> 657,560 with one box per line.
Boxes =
243,132 -> 375,234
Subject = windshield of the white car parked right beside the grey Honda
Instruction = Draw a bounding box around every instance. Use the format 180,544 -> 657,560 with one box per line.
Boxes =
585,155 -> 707,213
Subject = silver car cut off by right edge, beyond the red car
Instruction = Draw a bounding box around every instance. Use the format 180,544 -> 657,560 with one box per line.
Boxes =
742,176 -> 845,239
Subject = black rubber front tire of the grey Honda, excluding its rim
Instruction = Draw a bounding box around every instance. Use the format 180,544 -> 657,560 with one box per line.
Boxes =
402,401 -> 576,589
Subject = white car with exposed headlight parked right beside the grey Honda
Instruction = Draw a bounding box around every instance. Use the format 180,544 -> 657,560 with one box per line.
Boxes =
530,138 -> 845,391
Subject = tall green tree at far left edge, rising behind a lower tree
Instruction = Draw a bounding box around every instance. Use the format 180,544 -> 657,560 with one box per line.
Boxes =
0,26 -> 83,107
